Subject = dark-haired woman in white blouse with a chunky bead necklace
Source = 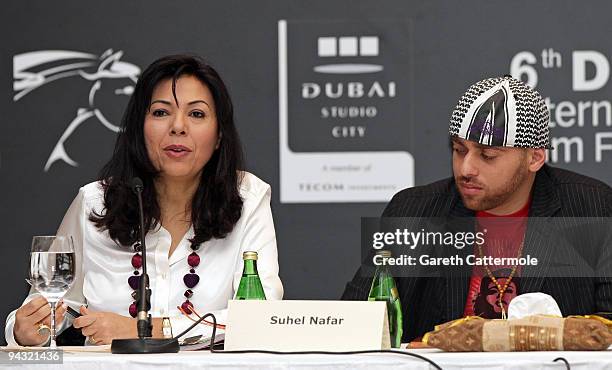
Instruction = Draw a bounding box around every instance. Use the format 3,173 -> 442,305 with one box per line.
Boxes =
5,55 -> 283,345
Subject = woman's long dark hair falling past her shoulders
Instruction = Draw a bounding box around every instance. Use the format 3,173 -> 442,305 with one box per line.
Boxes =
89,55 -> 243,245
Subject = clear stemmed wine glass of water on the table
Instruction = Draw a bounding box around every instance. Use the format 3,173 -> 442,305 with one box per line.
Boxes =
30,236 -> 75,348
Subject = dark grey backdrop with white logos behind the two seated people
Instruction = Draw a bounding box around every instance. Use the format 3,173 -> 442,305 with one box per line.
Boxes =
0,0 -> 612,344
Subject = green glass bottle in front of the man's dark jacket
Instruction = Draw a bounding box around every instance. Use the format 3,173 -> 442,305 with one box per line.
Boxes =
368,251 -> 403,348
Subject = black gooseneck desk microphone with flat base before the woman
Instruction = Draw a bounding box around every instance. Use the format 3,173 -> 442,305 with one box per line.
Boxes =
111,177 -> 179,353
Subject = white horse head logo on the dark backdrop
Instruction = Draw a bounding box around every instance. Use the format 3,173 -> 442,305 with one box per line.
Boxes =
13,49 -> 140,172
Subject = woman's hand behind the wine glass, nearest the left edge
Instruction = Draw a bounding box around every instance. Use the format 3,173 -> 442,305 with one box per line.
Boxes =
13,297 -> 66,346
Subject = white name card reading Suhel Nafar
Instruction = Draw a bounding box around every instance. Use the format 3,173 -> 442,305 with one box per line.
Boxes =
225,300 -> 390,352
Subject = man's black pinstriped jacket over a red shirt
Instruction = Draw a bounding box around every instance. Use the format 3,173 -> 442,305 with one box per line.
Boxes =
342,165 -> 612,342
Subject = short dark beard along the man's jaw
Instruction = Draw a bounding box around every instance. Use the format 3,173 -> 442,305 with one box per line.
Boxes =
455,166 -> 528,211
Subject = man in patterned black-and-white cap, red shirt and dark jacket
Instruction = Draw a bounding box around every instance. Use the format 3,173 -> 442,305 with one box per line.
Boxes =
342,76 -> 612,342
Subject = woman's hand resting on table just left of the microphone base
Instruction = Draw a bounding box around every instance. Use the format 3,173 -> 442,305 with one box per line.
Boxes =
73,306 -> 138,344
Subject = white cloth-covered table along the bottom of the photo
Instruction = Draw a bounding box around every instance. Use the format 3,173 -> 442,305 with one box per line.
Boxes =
0,349 -> 612,370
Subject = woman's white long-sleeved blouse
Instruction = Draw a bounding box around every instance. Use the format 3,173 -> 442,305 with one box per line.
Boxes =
5,172 -> 283,345
